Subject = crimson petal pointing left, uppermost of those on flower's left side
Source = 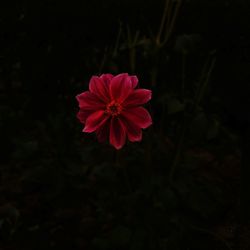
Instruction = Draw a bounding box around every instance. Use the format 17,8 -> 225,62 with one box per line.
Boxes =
76,91 -> 106,110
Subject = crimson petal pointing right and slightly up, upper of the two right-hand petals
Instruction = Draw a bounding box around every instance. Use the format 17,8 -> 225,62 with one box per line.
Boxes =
123,89 -> 152,107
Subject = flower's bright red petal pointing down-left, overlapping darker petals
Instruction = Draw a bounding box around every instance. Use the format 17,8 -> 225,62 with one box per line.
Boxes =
83,110 -> 108,133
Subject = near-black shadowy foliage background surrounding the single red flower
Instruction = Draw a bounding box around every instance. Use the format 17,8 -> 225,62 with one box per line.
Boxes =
0,0 -> 250,250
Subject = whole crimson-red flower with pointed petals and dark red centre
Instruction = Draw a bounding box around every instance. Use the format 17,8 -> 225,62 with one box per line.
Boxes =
76,73 -> 152,149
